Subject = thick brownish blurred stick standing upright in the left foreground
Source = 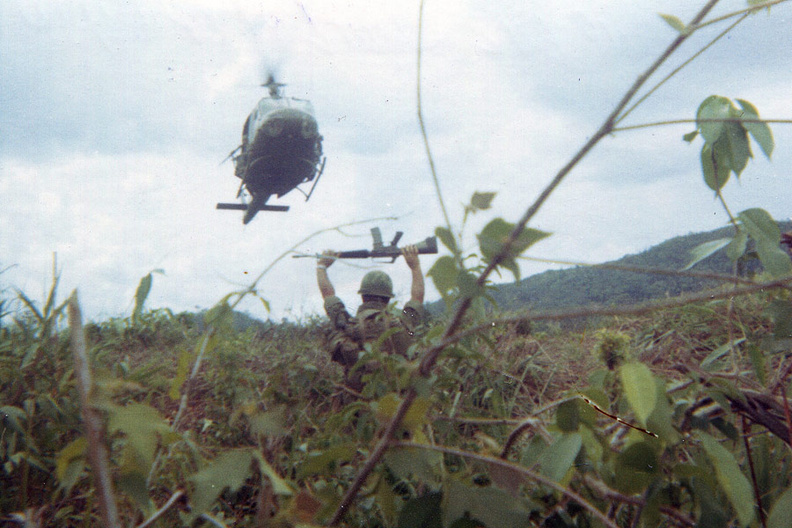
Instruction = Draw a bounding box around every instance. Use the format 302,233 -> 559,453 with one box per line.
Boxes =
68,290 -> 121,528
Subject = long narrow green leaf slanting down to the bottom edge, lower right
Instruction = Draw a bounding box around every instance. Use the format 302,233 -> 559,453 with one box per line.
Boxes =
698,431 -> 754,526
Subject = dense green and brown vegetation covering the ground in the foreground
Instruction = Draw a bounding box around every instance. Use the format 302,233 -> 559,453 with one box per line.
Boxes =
0,270 -> 792,527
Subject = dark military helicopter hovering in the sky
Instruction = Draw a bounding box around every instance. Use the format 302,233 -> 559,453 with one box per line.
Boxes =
217,74 -> 326,224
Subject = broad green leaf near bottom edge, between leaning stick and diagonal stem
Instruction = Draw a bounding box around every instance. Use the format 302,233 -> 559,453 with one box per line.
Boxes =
190,449 -> 253,512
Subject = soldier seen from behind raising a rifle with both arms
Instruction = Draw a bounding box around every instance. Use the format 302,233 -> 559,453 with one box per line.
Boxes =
316,245 -> 424,392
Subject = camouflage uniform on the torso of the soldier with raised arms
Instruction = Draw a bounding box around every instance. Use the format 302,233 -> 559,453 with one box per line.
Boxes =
325,295 -> 423,392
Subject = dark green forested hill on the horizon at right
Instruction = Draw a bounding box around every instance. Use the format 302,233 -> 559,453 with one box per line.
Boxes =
452,222 -> 792,311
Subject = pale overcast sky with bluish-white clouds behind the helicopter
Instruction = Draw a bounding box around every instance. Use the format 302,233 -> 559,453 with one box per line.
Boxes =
0,0 -> 792,320
